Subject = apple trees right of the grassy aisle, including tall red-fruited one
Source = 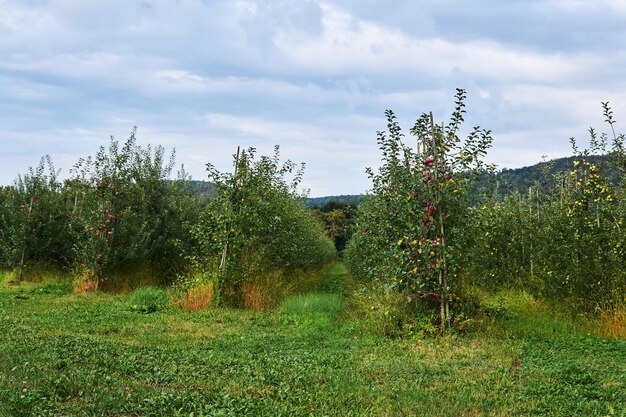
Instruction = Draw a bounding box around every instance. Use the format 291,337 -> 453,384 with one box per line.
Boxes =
346,90 -> 626,328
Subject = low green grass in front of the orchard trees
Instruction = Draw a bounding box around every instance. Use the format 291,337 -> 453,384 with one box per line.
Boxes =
0,265 -> 626,416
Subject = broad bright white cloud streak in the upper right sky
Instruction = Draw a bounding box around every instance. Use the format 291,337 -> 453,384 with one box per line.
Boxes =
276,6 -> 579,82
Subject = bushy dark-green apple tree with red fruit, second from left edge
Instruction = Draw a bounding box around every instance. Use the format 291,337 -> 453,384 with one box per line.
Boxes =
68,131 -> 194,279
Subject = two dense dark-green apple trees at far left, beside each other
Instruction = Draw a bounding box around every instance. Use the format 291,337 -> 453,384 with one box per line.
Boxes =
0,131 -> 198,289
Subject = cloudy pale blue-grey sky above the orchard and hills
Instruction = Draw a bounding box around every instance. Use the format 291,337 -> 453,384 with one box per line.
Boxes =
0,0 -> 626,196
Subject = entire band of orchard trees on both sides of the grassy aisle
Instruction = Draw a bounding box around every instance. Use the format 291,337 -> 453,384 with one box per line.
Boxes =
0,95 -> 626,322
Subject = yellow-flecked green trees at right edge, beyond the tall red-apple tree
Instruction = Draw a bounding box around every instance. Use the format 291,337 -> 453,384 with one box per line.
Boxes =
467,103 -> 626,312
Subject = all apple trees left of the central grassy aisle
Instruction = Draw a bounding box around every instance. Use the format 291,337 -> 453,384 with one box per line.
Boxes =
0,132 -> 335,304
